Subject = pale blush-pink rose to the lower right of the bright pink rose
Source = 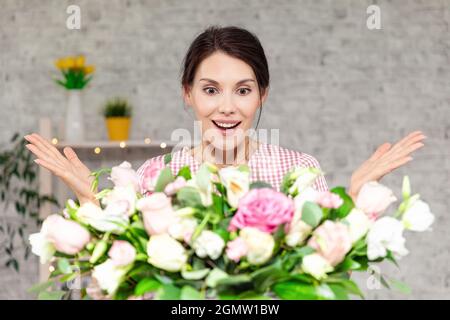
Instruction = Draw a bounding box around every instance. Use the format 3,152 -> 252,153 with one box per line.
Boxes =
308,220 -> 352,266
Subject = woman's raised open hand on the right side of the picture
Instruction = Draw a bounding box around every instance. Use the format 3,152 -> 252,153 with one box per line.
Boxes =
349,131 -> 426,200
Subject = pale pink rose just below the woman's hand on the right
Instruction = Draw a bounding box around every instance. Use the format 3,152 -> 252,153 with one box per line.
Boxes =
355,181 -> 397,217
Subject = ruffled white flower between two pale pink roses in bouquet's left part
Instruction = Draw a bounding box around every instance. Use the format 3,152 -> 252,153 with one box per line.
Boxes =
77,202 -> 129,234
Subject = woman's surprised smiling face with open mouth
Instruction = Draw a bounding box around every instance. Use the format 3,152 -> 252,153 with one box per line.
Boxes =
184,51 -> 268,150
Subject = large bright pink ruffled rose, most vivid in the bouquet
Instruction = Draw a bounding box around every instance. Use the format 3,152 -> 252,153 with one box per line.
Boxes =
228,188 -> 294,233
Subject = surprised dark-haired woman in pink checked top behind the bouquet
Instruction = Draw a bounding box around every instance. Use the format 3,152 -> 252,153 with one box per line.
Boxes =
25,27 -> 425,204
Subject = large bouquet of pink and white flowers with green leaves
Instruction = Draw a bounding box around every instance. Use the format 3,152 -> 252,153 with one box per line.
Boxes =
30,155 -> 434,299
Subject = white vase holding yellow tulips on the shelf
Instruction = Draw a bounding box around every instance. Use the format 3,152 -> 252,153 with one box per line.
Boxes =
55,55 -> 95,142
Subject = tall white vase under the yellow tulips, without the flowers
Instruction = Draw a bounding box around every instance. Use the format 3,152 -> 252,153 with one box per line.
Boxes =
65,90 -> 84,142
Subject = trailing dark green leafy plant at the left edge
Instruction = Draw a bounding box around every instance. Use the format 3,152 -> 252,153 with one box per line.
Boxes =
0,133 -> 59,271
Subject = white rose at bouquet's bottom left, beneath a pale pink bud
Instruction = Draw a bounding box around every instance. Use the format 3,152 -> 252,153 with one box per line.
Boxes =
92,259 -> 130,295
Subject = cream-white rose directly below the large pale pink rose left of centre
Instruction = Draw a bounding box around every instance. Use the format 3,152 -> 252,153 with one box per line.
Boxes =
147,233 -> 188,272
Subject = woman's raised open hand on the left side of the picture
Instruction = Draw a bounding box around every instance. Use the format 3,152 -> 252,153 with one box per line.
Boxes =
24,133 -> 99,205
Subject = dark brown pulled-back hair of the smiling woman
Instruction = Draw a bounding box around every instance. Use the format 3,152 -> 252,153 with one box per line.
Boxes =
181,26 -> 269,127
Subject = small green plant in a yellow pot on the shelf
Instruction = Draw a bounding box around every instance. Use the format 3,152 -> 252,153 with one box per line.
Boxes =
103,97 -> 132,141
